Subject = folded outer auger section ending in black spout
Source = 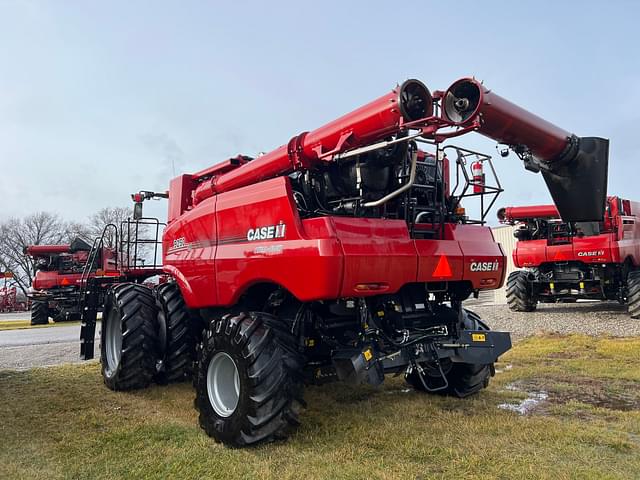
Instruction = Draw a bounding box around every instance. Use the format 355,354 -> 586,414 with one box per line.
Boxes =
442,78 -> 609,222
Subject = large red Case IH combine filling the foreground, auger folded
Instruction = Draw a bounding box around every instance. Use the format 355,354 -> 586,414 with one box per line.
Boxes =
81,79 -> 608,446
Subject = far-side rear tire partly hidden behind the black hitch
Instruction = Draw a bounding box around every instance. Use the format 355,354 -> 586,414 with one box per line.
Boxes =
404,310 -> 495,398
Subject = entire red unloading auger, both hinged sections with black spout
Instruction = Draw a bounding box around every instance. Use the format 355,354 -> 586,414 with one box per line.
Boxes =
184,78 -> 609,221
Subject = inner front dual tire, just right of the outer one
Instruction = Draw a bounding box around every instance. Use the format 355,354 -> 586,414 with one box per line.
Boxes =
154,282 -> 198,384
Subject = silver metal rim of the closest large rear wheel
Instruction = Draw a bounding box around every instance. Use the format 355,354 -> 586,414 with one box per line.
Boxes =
207,352 -> 240,417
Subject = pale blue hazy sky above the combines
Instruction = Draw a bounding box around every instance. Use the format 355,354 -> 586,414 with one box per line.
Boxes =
0,0 -> 640,225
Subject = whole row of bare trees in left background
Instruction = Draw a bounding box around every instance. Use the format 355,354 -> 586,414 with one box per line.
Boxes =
0,207 -> 132,295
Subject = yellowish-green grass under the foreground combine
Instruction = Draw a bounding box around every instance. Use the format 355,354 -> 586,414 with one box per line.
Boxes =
0,336 -> 640,480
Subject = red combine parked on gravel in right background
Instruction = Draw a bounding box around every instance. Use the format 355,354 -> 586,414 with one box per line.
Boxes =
498,197 -> 640,318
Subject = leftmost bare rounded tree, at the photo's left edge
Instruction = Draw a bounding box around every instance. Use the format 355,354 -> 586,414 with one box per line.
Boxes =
0,212 -> 73,294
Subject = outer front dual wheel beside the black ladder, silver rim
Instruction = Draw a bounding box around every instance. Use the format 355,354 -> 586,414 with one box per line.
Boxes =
100,283 -> 158,390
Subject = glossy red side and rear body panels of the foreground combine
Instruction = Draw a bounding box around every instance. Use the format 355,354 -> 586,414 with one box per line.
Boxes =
163,177 -> 505,308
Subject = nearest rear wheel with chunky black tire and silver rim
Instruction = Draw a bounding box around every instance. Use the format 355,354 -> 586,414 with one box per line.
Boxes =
194,312 -> 304,447
